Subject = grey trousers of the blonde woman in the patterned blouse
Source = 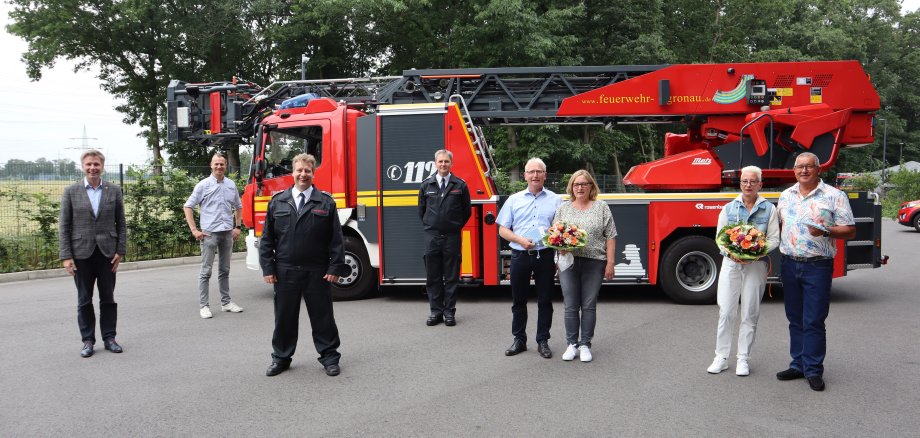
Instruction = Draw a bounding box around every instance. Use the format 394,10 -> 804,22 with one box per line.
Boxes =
559,257 -> 607,347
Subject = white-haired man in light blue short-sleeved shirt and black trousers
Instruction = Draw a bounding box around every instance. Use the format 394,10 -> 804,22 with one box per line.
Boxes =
496,158 -> 562,359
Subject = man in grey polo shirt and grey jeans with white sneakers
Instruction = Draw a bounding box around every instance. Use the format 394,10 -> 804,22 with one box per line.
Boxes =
184,153 -> 243,319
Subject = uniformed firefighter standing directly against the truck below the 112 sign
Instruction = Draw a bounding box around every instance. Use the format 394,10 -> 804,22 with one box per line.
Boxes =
418,149 -> 470,326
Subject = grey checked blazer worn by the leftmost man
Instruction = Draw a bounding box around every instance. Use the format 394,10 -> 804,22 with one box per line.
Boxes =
60,180 -> 127,260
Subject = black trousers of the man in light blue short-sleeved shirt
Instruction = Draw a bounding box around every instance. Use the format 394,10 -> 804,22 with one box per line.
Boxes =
511,249 -> 556,342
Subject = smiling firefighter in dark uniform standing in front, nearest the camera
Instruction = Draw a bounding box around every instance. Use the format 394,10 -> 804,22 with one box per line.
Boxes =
259,154 -> 348,376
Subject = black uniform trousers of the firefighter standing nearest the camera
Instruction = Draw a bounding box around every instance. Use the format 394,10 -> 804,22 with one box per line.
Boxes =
272,269 -> 342,366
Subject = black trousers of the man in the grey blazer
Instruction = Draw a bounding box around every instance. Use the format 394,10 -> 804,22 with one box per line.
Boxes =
73,247 -> 118,344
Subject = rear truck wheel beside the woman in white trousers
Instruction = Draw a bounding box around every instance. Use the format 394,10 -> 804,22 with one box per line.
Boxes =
659,236 -> 722,304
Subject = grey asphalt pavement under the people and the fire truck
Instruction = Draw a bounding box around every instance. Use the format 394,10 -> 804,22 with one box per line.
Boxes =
0,220 -> 920,437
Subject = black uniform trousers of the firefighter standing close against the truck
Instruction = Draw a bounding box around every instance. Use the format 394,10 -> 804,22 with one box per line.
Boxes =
425,233 -> 460,316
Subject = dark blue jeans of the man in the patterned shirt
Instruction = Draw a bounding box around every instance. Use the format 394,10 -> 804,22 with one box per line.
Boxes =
782,257 -> 834,377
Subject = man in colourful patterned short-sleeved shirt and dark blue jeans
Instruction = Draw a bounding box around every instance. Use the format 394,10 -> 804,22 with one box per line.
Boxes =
776,152 -> 856,391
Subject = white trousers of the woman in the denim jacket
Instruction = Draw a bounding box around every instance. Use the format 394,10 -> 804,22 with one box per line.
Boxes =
716,257 -> 767,360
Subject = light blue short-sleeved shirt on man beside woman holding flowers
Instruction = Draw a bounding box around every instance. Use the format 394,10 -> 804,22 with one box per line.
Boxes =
496,188 -> 562,251
